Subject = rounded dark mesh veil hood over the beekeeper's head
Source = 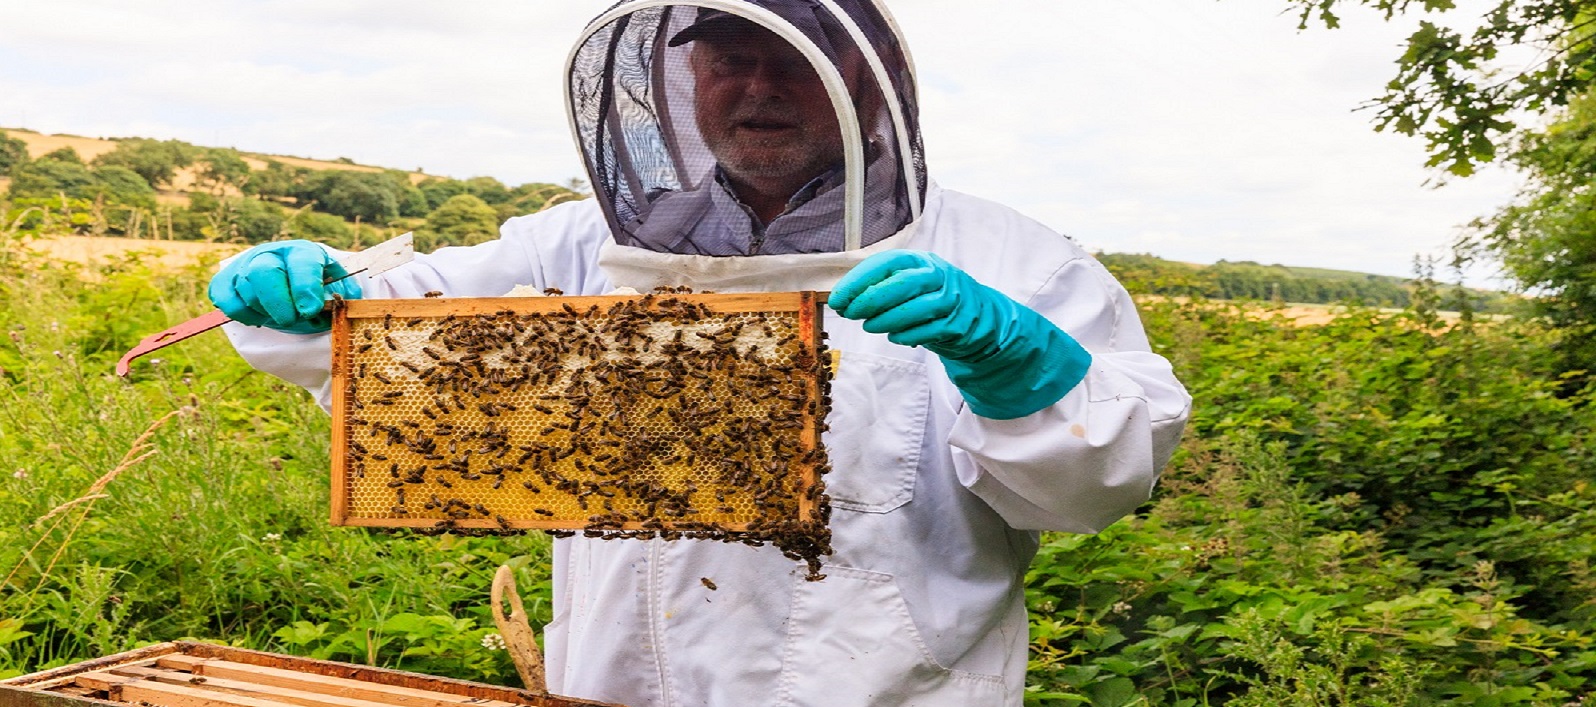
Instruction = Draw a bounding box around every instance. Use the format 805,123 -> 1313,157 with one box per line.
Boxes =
567,0 -> 926,255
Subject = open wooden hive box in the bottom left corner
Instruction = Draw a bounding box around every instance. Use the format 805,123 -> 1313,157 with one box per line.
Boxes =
0,642 -> 621,707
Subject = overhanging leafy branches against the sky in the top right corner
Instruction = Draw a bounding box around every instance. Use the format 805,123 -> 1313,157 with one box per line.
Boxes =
1286,0 -> 1596,176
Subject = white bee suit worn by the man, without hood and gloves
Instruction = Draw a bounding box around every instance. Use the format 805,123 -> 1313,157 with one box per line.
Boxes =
227,187 -> 1189,707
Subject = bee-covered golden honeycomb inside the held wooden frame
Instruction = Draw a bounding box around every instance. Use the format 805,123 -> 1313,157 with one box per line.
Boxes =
335,292 -> 830,579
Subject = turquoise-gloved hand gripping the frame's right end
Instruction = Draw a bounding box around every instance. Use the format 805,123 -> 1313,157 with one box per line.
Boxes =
827,251 -> 1092,420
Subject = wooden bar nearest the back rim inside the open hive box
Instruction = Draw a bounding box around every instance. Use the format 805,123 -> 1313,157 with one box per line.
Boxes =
158,654 -> 512,707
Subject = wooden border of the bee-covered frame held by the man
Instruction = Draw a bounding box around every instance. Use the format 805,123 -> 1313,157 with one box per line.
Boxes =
330,292 -> 825,531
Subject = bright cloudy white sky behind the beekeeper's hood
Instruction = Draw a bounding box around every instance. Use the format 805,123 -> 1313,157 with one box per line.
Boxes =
0,0 -> 1518,284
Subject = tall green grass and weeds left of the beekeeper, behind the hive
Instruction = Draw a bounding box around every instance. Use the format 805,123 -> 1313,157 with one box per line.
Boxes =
0,234 -> 547,681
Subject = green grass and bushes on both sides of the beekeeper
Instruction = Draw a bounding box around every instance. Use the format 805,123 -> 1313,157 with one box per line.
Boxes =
0,228 -> 1596,707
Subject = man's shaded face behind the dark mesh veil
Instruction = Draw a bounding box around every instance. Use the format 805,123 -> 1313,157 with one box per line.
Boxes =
693,22 -> 843,195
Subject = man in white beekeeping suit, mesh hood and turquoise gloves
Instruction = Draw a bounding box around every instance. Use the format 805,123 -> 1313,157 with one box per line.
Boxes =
211,0 -> 1189,707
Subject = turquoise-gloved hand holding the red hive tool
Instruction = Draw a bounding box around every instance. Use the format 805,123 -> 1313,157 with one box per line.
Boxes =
209,241 -> 361,334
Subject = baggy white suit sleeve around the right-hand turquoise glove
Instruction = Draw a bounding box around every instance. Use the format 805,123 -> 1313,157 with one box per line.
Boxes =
948,257 -> 1191,533
